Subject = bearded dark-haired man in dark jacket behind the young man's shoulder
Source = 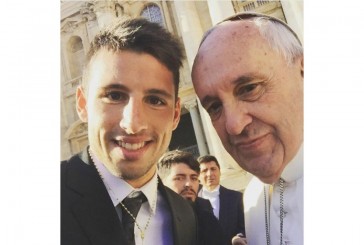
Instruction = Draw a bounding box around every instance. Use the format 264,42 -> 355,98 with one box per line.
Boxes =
158,150 -> 223,245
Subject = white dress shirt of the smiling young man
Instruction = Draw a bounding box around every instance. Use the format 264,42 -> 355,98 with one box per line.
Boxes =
92,155 -> 173,245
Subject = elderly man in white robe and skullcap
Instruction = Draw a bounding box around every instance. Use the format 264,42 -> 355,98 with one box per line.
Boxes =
192,13 -> 303,245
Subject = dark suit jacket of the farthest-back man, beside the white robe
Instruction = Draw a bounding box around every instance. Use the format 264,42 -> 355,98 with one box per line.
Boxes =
219,185 -> 245,244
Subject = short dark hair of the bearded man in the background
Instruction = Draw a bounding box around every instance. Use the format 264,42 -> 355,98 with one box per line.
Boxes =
158,150 -> 200,179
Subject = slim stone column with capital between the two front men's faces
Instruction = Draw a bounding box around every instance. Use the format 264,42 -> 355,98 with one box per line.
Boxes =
184,100 -> 208,155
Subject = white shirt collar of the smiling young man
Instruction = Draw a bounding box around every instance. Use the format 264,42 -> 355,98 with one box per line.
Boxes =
92,151 -> 158,214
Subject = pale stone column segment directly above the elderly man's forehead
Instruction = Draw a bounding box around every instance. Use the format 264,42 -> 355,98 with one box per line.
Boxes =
207,0 -> 235,25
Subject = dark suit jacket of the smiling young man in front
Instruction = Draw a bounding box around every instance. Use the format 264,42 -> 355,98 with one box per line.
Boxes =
61,150 -> 197,245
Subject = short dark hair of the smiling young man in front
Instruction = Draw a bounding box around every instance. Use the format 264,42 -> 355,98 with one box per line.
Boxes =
82,18 -> 185,99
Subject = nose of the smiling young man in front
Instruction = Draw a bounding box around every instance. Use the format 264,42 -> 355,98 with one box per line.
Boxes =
120,98 -> 147,134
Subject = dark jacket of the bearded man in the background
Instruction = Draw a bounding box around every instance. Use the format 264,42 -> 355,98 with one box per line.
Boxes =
194,197 -> 223,245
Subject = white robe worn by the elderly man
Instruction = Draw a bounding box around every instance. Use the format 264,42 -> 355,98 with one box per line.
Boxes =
244,145 -> 303,245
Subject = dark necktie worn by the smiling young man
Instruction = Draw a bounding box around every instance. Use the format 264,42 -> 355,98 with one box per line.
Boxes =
121,192 -> 147,245
